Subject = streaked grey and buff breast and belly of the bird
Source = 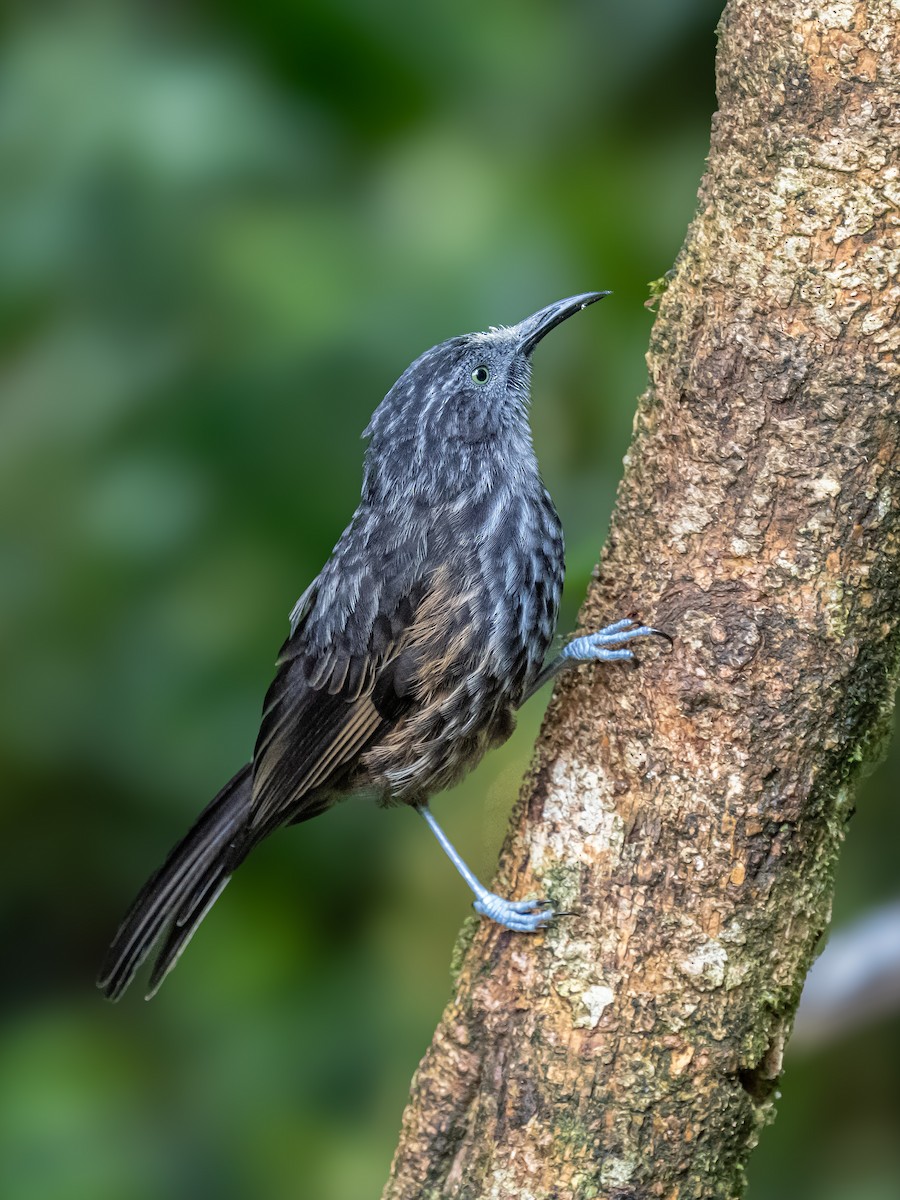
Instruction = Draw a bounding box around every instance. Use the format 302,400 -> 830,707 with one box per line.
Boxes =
364,482 -> 564,803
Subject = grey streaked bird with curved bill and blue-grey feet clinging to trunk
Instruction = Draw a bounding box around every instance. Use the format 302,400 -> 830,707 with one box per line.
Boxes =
97,292 -> 671,1000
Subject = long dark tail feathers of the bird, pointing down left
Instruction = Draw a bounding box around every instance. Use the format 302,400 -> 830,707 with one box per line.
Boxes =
97,763 -> 253,1000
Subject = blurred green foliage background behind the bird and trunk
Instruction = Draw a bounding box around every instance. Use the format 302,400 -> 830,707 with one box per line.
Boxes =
0,0 -> 900,1200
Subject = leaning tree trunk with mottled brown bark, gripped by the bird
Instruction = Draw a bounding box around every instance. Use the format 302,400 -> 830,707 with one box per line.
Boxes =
385,0 -> 900,1200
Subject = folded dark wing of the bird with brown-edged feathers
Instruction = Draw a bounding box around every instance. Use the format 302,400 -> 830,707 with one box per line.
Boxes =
248,564 -> 433,841
